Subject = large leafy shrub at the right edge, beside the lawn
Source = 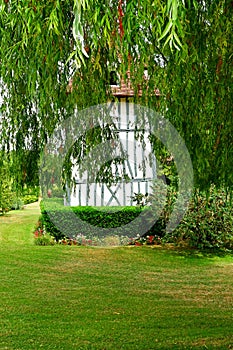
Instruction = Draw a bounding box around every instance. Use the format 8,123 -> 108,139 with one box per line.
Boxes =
173,186 -> 233,249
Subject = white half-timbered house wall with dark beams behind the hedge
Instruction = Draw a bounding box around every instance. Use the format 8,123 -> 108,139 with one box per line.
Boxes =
66,97 -> 156,206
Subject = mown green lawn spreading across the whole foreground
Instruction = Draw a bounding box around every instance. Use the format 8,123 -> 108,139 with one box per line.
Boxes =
0,204 -> 233,350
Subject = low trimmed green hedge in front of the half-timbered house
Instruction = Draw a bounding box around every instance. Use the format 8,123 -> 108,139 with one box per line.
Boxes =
41,199 -> 157,240
